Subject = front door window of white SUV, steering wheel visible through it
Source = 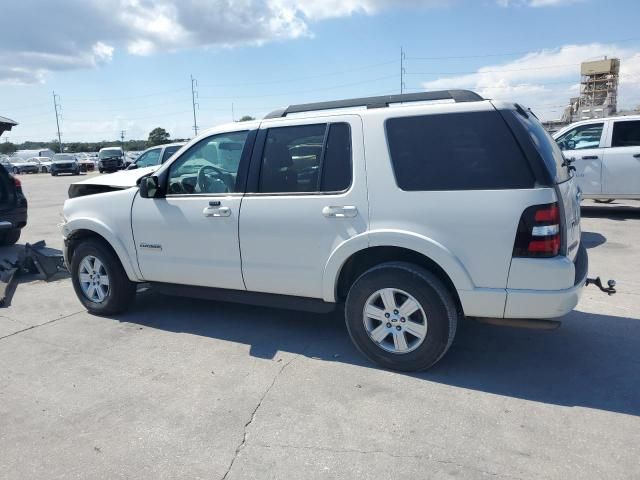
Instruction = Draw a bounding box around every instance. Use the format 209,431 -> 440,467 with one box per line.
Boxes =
167,131 -> 249,195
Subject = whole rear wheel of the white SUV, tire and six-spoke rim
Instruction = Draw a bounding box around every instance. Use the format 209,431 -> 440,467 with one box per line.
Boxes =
345,262 -> 459,371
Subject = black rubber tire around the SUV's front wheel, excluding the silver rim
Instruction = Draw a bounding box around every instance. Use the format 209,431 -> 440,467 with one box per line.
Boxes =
71,240 -> 136,315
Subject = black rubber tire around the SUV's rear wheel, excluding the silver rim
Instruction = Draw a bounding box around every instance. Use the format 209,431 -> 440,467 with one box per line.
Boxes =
345,262 -> 460,372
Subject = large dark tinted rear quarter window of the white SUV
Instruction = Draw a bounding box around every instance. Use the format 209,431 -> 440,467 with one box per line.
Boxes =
386,112 -> 534,191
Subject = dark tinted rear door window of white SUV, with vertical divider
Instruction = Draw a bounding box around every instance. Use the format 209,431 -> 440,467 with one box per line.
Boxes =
259,123 -> 352,193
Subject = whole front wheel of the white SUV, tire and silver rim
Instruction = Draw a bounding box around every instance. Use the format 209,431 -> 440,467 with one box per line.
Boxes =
71,240 -> 136,315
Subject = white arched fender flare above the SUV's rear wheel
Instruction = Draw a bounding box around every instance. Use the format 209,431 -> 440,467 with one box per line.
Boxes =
322,230 -> 474,302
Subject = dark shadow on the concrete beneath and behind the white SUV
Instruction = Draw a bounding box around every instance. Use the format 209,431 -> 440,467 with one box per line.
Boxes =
119,292 -> 640,415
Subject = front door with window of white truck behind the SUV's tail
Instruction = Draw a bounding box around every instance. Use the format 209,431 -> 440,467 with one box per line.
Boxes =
557,122 -> 604,195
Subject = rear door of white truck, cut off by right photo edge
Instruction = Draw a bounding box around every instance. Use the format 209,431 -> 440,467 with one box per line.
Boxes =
602,119 -> 640,196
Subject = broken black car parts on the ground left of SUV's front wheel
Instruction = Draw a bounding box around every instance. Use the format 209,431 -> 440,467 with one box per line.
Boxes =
0,240 -> 67,307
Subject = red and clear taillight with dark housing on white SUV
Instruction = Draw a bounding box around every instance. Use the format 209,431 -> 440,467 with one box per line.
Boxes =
513,203 -> 562,257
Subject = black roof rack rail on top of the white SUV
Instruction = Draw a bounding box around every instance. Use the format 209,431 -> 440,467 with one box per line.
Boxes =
264,90 -> 484,119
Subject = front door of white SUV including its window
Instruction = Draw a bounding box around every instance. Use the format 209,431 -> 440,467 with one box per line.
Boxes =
132,131 -> 250,290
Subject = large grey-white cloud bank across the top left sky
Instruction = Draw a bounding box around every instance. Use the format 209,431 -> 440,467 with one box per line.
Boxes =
0,0 -> 444,83
